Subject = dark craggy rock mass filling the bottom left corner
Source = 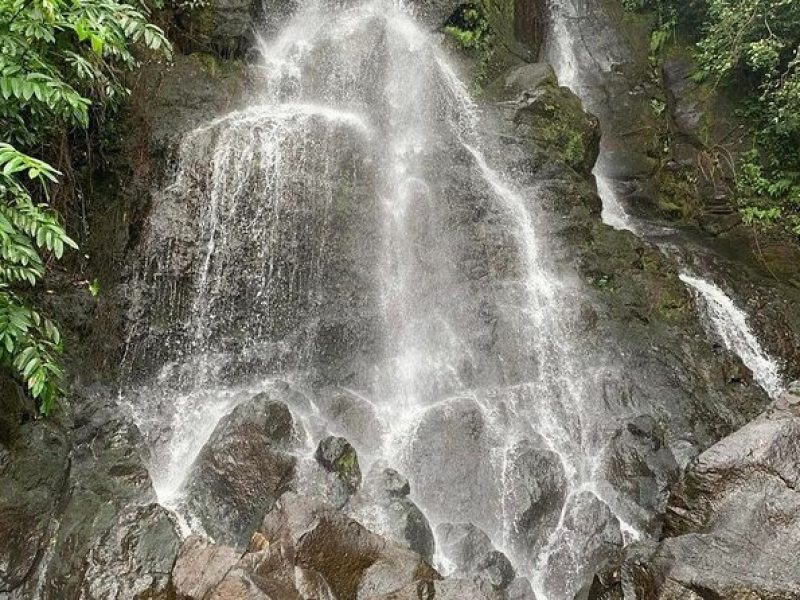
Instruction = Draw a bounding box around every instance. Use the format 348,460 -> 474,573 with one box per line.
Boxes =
0,390 -> 179,600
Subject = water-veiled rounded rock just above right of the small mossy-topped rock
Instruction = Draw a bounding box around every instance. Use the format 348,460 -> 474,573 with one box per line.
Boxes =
317,390 -> 383,452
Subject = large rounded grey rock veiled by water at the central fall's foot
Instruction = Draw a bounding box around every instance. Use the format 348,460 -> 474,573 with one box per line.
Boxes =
405,399 -> 500,530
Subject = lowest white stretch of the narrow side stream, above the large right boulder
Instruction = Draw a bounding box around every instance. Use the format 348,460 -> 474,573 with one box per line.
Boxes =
680,273 -> 786,398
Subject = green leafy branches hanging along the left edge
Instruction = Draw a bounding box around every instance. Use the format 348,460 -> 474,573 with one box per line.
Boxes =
0,0 -> 170,414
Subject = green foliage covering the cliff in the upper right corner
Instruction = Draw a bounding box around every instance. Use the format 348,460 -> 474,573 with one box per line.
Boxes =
624,0 -> 800,235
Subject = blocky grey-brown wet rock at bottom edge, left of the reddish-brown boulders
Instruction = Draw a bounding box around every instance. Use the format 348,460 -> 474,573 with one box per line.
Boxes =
81,504 -> 180,600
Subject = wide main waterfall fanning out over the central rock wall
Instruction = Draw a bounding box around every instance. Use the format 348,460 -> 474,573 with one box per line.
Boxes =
117,1 -> 656,600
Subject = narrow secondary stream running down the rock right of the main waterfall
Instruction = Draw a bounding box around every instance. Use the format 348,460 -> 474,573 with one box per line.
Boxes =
545,0 -> 785,397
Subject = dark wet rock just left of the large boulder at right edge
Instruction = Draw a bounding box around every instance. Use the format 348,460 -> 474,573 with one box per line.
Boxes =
604,415 -> 678,533
